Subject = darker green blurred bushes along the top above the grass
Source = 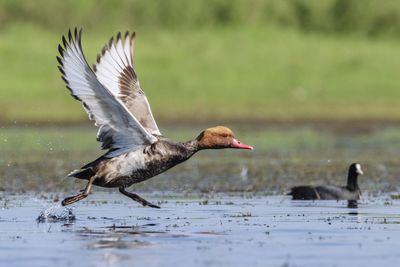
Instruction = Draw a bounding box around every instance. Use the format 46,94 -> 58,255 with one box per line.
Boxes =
0,0 -> 400,36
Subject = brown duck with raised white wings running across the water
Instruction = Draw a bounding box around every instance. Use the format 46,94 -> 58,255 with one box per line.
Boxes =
56,28 -> 253,208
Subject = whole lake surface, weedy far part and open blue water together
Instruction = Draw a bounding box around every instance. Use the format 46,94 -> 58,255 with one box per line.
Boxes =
0,125 -> 400,267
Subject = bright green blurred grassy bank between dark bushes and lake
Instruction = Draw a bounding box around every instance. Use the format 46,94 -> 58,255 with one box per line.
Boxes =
0,23 -> 400,123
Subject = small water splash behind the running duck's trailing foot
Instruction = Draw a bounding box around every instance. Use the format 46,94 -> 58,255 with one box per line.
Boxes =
36,204 -> 75,223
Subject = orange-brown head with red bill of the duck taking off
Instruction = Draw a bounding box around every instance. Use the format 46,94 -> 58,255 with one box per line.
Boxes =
196,126 -> 253,150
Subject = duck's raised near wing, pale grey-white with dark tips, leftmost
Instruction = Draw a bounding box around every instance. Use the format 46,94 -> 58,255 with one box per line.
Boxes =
57,28 -> 157,157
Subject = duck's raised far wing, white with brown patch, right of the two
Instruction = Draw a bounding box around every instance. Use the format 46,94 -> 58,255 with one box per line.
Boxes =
93,32 -> 161,135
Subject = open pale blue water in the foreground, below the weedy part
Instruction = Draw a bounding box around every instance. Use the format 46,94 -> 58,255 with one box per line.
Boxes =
0,193 -> 400,267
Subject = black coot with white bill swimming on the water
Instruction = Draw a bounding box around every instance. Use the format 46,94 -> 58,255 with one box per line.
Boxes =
288,163 -> 364,200
